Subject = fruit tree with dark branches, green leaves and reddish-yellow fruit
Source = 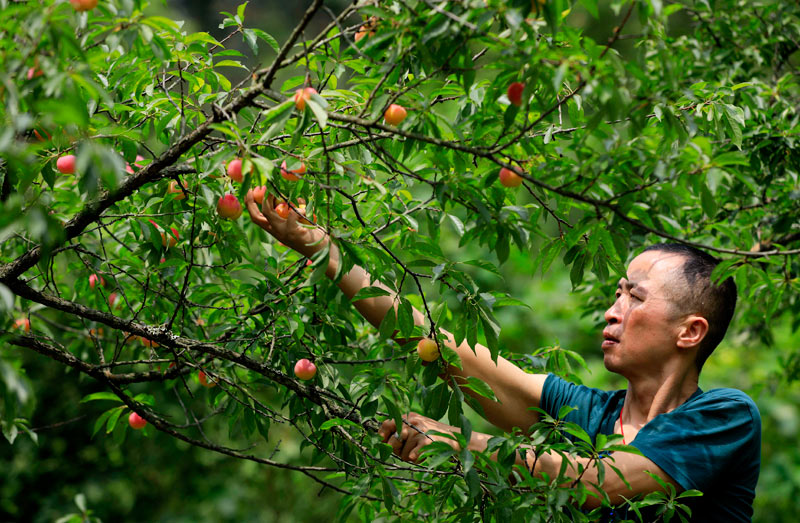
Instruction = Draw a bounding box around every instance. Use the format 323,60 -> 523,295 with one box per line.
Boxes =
0,0 -> 800,521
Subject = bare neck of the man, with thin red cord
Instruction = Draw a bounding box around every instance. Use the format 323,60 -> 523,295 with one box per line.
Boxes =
623,370 -> 699,427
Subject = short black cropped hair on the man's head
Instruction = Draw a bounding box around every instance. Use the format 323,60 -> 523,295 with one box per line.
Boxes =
643,243 -> 736,372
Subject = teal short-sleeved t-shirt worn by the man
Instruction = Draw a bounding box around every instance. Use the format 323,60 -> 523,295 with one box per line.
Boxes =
540,374 -> 761,523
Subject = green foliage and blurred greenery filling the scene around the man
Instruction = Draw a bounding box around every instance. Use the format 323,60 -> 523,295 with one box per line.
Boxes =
0,0 -> 800,522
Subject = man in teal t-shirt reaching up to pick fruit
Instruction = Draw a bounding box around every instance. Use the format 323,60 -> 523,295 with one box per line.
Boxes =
245,193 -> 761,522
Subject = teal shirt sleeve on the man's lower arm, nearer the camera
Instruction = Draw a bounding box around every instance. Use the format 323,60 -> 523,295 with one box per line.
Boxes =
630,389 -> 761,491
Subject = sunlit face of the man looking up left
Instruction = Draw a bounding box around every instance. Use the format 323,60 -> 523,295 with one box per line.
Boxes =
602,251 -> 684,379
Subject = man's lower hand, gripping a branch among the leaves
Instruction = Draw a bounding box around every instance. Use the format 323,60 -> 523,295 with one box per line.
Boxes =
378,412 -> 461,463
